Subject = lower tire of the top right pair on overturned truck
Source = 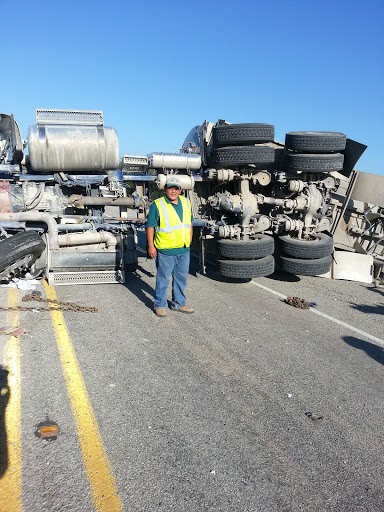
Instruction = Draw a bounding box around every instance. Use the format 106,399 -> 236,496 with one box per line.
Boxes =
285,153 -> 344,172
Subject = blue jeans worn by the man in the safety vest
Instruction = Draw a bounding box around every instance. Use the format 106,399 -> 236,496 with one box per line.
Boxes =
153,251 -> 190,309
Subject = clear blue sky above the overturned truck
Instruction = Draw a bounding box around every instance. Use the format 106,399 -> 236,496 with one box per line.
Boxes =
0,0 -> 384,174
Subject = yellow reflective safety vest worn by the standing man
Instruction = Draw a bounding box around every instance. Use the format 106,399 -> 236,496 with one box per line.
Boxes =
154,196 -> 192,249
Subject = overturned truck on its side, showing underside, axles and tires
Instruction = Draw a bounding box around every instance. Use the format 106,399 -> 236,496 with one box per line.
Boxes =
0,109 -> 378,284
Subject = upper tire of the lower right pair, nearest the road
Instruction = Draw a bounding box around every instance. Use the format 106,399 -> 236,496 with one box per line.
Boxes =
279,233 -> 333,260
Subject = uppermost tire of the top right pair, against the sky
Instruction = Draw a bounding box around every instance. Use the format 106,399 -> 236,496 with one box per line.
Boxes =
285,132 -> 347,153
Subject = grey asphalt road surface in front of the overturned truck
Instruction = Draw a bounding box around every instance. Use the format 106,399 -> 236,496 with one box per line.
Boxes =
0,253 -> 384,512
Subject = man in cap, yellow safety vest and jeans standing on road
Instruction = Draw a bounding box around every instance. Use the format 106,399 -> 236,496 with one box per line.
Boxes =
147,178 -> 193,317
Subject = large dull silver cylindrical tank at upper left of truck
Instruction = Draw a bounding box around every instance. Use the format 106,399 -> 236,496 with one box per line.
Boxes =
28,124 -> 119,172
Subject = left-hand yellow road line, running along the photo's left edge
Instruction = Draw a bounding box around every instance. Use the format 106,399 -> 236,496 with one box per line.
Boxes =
0,288 -> 22,512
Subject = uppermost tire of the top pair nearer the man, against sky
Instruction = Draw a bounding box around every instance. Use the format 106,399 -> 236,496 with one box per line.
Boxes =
212,123 -> 275,147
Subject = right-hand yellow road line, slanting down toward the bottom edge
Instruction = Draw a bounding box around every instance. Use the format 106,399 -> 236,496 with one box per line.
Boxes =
44,283 -> 124,512
